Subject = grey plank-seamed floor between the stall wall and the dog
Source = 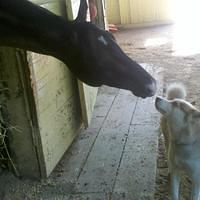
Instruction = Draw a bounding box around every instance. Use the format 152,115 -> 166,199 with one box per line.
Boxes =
0,64 -> 159,200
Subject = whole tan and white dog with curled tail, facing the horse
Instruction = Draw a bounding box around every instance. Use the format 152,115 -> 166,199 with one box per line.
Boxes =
155,84 -> 200,200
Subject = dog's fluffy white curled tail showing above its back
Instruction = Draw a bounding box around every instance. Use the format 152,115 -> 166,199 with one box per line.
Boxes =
167,83 -> 187,100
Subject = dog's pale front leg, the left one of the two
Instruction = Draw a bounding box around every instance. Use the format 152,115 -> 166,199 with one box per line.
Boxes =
170,171 -> 180,200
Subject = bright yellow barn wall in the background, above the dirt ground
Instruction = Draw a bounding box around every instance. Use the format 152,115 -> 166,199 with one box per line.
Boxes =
107,0 -> 172,25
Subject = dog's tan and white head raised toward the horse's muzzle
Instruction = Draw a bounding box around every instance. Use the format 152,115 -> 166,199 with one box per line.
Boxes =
155,97 -> 200,144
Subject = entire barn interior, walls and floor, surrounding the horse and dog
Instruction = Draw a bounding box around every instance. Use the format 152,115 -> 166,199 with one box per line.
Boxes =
0,0 -> 200,200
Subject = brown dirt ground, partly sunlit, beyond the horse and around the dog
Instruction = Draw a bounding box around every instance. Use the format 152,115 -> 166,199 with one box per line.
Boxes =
116,25 -> 200,200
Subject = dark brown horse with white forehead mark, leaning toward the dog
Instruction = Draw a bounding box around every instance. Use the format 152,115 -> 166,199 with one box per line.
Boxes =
0,0 -> 156,98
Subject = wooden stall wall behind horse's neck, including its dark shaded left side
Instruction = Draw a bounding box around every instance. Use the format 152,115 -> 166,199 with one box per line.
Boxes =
0,0 -> 82,178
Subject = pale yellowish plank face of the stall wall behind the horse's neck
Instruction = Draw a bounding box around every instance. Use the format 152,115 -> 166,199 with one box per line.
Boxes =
29,0 -> 82,177
